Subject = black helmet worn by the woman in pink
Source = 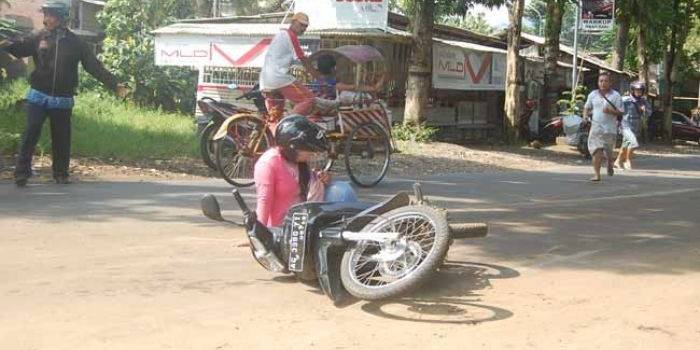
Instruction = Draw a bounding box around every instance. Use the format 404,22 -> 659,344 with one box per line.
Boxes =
275,114 -> 328,156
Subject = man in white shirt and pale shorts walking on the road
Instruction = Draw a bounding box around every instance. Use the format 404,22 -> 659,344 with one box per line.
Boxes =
583,71 -> 624,182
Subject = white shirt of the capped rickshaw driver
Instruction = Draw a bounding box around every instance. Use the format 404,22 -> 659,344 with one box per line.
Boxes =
260,29 -> 304,91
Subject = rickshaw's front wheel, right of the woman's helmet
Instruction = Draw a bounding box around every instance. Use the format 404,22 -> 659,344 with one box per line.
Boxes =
345,122 -> 391,187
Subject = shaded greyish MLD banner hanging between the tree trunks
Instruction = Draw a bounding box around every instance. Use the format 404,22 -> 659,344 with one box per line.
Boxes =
433,42 -> 506,90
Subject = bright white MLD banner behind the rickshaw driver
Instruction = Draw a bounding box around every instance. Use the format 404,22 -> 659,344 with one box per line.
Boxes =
155,34 -> 320,68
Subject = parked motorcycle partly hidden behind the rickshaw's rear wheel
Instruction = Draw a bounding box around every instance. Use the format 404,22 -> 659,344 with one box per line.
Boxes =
197,84 -> 266,170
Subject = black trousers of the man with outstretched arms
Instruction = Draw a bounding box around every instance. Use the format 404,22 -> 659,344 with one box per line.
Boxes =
15,103 -> 73,178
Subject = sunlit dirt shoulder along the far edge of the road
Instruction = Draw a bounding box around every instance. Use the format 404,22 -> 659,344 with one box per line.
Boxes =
0,142 -> 700,182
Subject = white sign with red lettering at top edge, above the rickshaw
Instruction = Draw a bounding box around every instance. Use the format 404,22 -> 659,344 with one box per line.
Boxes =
294,0 -> 389,30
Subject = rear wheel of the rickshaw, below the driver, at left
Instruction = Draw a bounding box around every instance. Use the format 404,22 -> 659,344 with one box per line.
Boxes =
216,116 -> 273,187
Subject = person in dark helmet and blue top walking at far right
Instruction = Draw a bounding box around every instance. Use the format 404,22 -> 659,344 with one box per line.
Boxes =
615,81 -> 651,170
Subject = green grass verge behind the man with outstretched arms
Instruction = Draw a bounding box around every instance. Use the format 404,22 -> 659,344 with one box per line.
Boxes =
0,80 -> 198,160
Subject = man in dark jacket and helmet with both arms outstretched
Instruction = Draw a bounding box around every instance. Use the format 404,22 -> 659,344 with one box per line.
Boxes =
0,1 -> 127,187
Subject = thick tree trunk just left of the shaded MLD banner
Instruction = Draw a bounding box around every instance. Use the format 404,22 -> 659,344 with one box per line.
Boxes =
404,0 -> 435,125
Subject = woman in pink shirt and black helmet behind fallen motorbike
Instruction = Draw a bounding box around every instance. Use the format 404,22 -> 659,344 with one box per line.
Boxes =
254,115 -> 357,227
